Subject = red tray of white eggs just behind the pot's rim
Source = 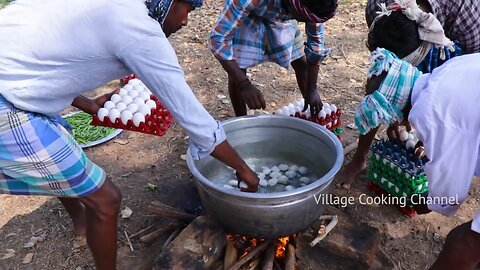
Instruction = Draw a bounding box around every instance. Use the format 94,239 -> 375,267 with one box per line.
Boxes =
275,99 -> 342,136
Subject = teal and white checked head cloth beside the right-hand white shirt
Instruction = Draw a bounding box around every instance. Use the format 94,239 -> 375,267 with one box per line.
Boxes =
355,48 -> 421,135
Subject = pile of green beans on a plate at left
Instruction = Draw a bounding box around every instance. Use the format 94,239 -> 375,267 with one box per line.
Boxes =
64,112 -> 115,144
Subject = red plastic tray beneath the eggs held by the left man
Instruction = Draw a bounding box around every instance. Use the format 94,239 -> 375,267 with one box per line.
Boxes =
90,95 -> 173,136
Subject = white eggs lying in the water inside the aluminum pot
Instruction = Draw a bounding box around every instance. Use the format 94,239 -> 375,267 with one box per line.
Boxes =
223,164 -> 314,192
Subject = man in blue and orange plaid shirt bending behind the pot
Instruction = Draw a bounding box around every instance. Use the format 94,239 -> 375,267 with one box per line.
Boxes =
210,0 -> 337,116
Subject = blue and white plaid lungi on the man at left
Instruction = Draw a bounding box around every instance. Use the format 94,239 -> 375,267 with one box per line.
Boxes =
0,96 -> 106,197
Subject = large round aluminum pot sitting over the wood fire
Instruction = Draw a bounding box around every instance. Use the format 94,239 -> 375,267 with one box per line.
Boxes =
187,115 -> 343,238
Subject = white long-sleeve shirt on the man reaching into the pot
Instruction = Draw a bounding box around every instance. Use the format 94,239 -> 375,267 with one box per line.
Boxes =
0,0 -> 225,158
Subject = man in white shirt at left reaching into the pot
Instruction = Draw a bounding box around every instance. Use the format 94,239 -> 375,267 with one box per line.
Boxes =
0,0 -> 258,269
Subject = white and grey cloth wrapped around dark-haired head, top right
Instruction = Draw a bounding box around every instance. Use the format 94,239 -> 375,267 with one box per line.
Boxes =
370,0 -> 455,66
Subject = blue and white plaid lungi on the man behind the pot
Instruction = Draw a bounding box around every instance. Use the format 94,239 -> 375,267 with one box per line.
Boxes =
233,21 -> 305,68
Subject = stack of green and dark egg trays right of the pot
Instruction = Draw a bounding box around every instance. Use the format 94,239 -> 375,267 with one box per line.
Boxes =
368,131 -> 428,207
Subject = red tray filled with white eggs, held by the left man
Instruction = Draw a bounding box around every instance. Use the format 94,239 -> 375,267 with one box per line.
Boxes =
92,79 -> 173,136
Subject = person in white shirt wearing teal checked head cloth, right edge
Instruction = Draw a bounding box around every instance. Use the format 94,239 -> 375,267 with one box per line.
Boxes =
355,49 -> 480,269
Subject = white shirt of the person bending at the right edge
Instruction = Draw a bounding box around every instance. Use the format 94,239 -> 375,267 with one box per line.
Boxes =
408,54 -> 480,233
